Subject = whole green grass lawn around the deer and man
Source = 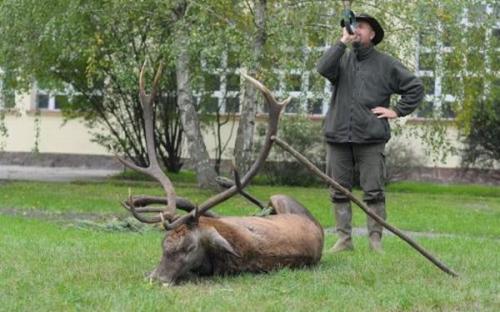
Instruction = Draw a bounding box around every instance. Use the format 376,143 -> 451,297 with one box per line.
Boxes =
0,181 -> 500,311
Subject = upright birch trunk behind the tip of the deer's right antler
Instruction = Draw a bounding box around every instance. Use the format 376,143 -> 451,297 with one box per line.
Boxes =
234,0 -> 267,174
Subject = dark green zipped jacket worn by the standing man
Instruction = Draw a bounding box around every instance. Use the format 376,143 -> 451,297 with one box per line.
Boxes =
317,41 -> 424,144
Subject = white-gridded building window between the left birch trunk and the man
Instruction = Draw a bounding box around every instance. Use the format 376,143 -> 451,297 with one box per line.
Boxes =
194,45 -> 331,115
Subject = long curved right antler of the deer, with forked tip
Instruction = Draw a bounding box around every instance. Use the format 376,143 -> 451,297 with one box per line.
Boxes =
169,74 -> 291,228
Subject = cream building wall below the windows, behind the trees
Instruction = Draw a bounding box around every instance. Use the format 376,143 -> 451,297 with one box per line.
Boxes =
3,89 -> 468,168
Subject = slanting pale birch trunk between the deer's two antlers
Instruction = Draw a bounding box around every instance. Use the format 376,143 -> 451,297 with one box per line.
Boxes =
175,33 -> 218,189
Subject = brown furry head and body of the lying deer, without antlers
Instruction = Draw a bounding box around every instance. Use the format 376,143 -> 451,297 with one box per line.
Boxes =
146,195 -> 324,283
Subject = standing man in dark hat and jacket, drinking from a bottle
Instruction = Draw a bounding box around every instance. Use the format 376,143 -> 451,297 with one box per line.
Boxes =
317,14 -> 424,252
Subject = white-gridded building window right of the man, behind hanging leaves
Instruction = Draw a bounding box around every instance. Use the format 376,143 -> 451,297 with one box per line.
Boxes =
415,4 -> 500,118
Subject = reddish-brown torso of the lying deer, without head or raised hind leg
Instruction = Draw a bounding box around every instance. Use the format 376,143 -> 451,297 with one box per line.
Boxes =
200,214 -> 324,273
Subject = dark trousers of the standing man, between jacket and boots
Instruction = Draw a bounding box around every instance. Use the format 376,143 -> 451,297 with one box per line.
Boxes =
326,143 -> 386,203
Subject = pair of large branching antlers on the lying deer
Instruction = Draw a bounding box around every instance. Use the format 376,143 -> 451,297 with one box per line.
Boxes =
117,68 -> 291,230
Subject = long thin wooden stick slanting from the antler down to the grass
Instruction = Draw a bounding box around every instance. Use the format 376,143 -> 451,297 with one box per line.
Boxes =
271,136 -> 458,277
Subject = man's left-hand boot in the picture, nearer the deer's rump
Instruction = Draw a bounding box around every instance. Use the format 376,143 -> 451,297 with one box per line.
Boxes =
331,201 -> 354,253
